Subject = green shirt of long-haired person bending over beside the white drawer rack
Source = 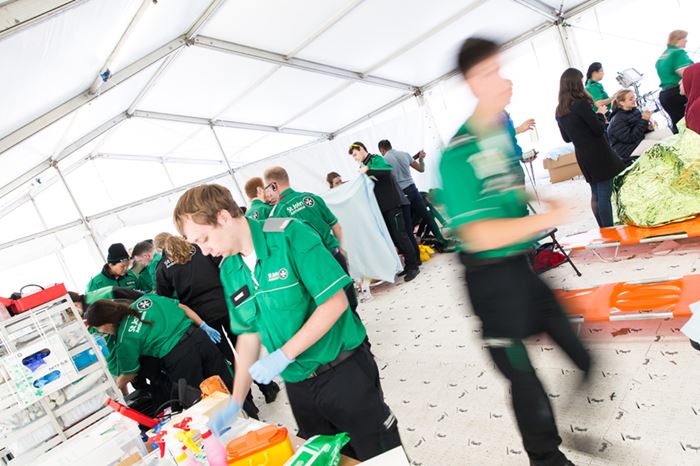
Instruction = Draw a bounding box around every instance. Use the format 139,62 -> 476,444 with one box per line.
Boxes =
109,293 -> 192,376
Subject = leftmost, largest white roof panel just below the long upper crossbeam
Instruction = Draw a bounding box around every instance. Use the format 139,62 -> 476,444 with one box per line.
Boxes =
138,47 -> 275,118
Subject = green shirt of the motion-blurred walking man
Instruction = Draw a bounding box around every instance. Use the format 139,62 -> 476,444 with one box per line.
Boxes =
440,123 -> 533,258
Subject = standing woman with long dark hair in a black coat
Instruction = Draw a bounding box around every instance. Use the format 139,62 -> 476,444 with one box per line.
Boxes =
556,68 -> 625,228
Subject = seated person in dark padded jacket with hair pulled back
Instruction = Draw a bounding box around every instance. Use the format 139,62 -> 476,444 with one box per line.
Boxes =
608,89 -> 653,165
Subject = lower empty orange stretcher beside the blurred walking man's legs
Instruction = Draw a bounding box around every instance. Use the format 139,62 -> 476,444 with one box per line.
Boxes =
555,275 -> 700,322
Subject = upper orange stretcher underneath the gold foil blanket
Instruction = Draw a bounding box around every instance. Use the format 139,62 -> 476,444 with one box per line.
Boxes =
560,217 -> 700,251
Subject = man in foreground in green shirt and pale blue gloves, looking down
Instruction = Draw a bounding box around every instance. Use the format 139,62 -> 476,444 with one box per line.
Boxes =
173,185 -> 401,460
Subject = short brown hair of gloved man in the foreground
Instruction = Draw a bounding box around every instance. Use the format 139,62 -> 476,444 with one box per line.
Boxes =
173,184 -> 243,234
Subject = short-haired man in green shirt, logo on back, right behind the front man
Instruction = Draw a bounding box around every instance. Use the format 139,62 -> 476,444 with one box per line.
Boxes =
265,167 -> 357,312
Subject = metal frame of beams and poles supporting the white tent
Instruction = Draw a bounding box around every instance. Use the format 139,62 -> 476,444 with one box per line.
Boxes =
0,0 -> 604,258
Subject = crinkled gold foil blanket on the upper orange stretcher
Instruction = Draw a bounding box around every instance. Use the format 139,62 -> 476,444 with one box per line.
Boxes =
613,125 -> 700,227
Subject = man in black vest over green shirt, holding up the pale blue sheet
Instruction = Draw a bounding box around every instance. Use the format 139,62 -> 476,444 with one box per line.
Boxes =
348,142 -> 420,282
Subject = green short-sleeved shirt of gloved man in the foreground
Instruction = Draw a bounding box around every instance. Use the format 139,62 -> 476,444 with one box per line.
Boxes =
221,219 -> 366,382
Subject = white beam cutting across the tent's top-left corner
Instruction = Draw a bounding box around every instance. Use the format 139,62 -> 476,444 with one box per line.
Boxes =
0,0 -> 90,41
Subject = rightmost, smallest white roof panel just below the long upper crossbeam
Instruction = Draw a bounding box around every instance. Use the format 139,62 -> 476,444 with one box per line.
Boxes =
289,83 -> 404,132
